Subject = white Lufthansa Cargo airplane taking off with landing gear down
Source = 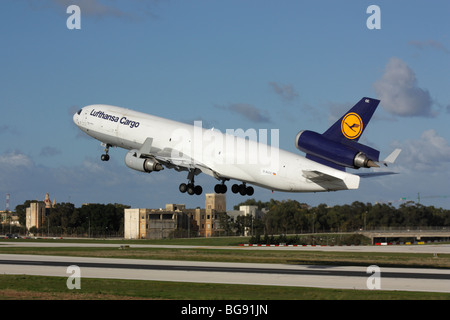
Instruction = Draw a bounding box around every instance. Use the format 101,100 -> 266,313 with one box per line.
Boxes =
73,98 -> 401,195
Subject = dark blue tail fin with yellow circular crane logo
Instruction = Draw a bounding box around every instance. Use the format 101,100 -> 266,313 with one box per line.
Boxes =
323,97 -> 380,143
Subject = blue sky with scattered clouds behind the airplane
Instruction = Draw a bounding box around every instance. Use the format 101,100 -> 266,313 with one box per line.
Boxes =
0,0 -> 450,209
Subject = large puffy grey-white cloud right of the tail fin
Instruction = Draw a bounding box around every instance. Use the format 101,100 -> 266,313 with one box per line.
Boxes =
373,57 -> 435,117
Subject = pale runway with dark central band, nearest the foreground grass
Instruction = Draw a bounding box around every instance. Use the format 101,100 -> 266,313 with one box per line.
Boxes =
0,254 -> 450,293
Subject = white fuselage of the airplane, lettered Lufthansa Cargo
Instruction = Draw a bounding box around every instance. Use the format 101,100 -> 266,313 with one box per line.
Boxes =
73,105 -> 359,192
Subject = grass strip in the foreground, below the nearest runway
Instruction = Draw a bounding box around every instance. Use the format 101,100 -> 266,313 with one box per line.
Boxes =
0,275 -> 450,300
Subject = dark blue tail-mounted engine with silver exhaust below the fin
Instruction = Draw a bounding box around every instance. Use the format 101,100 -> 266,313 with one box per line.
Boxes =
295,130 -> 379,169
